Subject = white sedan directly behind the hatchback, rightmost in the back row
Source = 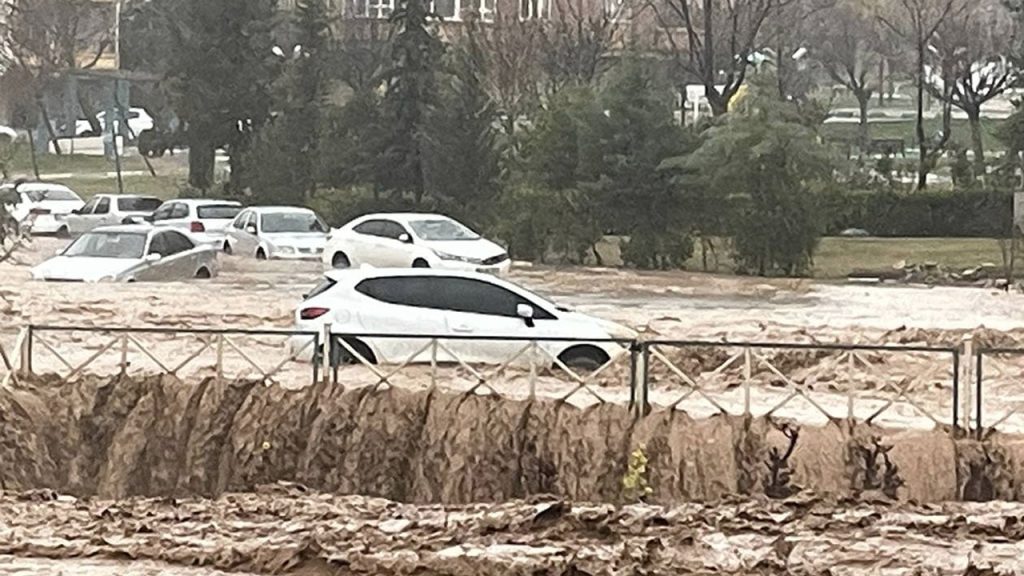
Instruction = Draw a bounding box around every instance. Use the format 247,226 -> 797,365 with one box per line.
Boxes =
324,213 -> 511,275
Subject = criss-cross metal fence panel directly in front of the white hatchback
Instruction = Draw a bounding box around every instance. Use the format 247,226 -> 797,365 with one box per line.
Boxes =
328,333 -> 637,405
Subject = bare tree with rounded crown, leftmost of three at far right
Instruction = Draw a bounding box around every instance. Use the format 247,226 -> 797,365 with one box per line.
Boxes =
811,0 -> 884,147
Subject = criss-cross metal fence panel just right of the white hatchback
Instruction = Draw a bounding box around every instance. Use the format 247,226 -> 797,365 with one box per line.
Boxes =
642,341 -> 962,427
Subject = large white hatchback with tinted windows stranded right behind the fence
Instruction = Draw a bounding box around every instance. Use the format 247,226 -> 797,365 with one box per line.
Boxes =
291,269 -> 636,370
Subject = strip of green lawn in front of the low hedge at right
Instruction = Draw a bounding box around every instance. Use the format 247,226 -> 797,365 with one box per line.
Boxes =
814,238 -> 1002,278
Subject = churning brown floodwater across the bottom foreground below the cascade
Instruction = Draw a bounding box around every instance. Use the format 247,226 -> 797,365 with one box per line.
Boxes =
0,485 -> 1024,576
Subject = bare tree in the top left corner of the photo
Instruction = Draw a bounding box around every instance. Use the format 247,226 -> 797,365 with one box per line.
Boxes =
0,0 -> 114,154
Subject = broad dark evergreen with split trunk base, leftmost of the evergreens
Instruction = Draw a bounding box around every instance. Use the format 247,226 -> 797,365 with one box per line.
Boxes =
167,0 -> 278,193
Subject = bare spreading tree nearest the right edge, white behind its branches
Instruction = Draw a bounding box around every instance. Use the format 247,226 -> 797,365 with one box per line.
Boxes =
926,0 -> 1019,168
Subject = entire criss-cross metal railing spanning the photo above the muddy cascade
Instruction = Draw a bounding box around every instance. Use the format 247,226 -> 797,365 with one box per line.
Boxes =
0,325 -> 1024,438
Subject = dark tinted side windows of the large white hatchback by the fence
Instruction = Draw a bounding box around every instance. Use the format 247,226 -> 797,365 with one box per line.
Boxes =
355,276 -> 554,320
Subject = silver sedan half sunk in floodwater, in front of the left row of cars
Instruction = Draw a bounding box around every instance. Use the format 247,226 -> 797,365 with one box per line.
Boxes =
32,224 -> 219,282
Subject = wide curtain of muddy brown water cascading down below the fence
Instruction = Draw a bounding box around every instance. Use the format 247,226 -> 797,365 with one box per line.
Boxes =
0,377 -> 1024,503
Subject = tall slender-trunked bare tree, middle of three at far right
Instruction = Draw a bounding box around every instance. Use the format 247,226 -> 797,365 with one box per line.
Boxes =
879,0 -> 971,190
